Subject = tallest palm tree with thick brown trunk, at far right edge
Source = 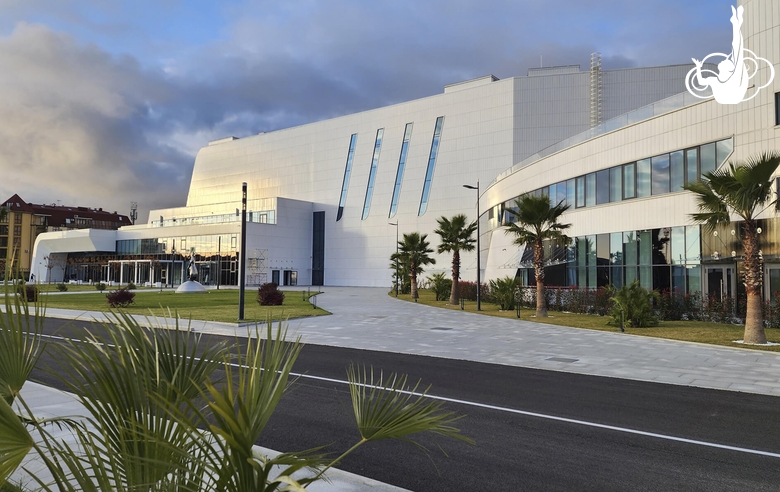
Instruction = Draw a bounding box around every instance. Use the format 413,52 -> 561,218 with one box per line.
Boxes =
685,152 -> 780,344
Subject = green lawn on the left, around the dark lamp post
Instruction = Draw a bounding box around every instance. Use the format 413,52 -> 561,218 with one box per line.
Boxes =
41,287 -> 330,323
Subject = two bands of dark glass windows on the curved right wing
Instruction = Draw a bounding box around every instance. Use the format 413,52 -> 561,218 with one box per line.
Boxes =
506,138 -> 736,293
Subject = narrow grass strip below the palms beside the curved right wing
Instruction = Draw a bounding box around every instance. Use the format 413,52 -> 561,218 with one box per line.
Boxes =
390,289 -> 780,352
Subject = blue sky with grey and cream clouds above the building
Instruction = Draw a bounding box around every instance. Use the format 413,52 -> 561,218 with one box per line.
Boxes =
0,0 -> 735,221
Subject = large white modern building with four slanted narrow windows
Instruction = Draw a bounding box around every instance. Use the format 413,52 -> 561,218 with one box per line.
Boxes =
33,0 -> 780,302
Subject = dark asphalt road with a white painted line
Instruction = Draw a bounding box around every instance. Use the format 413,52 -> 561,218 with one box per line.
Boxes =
27,319 -> 780,491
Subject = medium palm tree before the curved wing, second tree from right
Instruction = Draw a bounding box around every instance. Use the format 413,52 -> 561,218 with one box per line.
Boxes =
504,195 -> 571,317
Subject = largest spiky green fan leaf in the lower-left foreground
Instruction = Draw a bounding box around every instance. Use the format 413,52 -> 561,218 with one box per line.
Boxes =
53,314 -> 226,490
